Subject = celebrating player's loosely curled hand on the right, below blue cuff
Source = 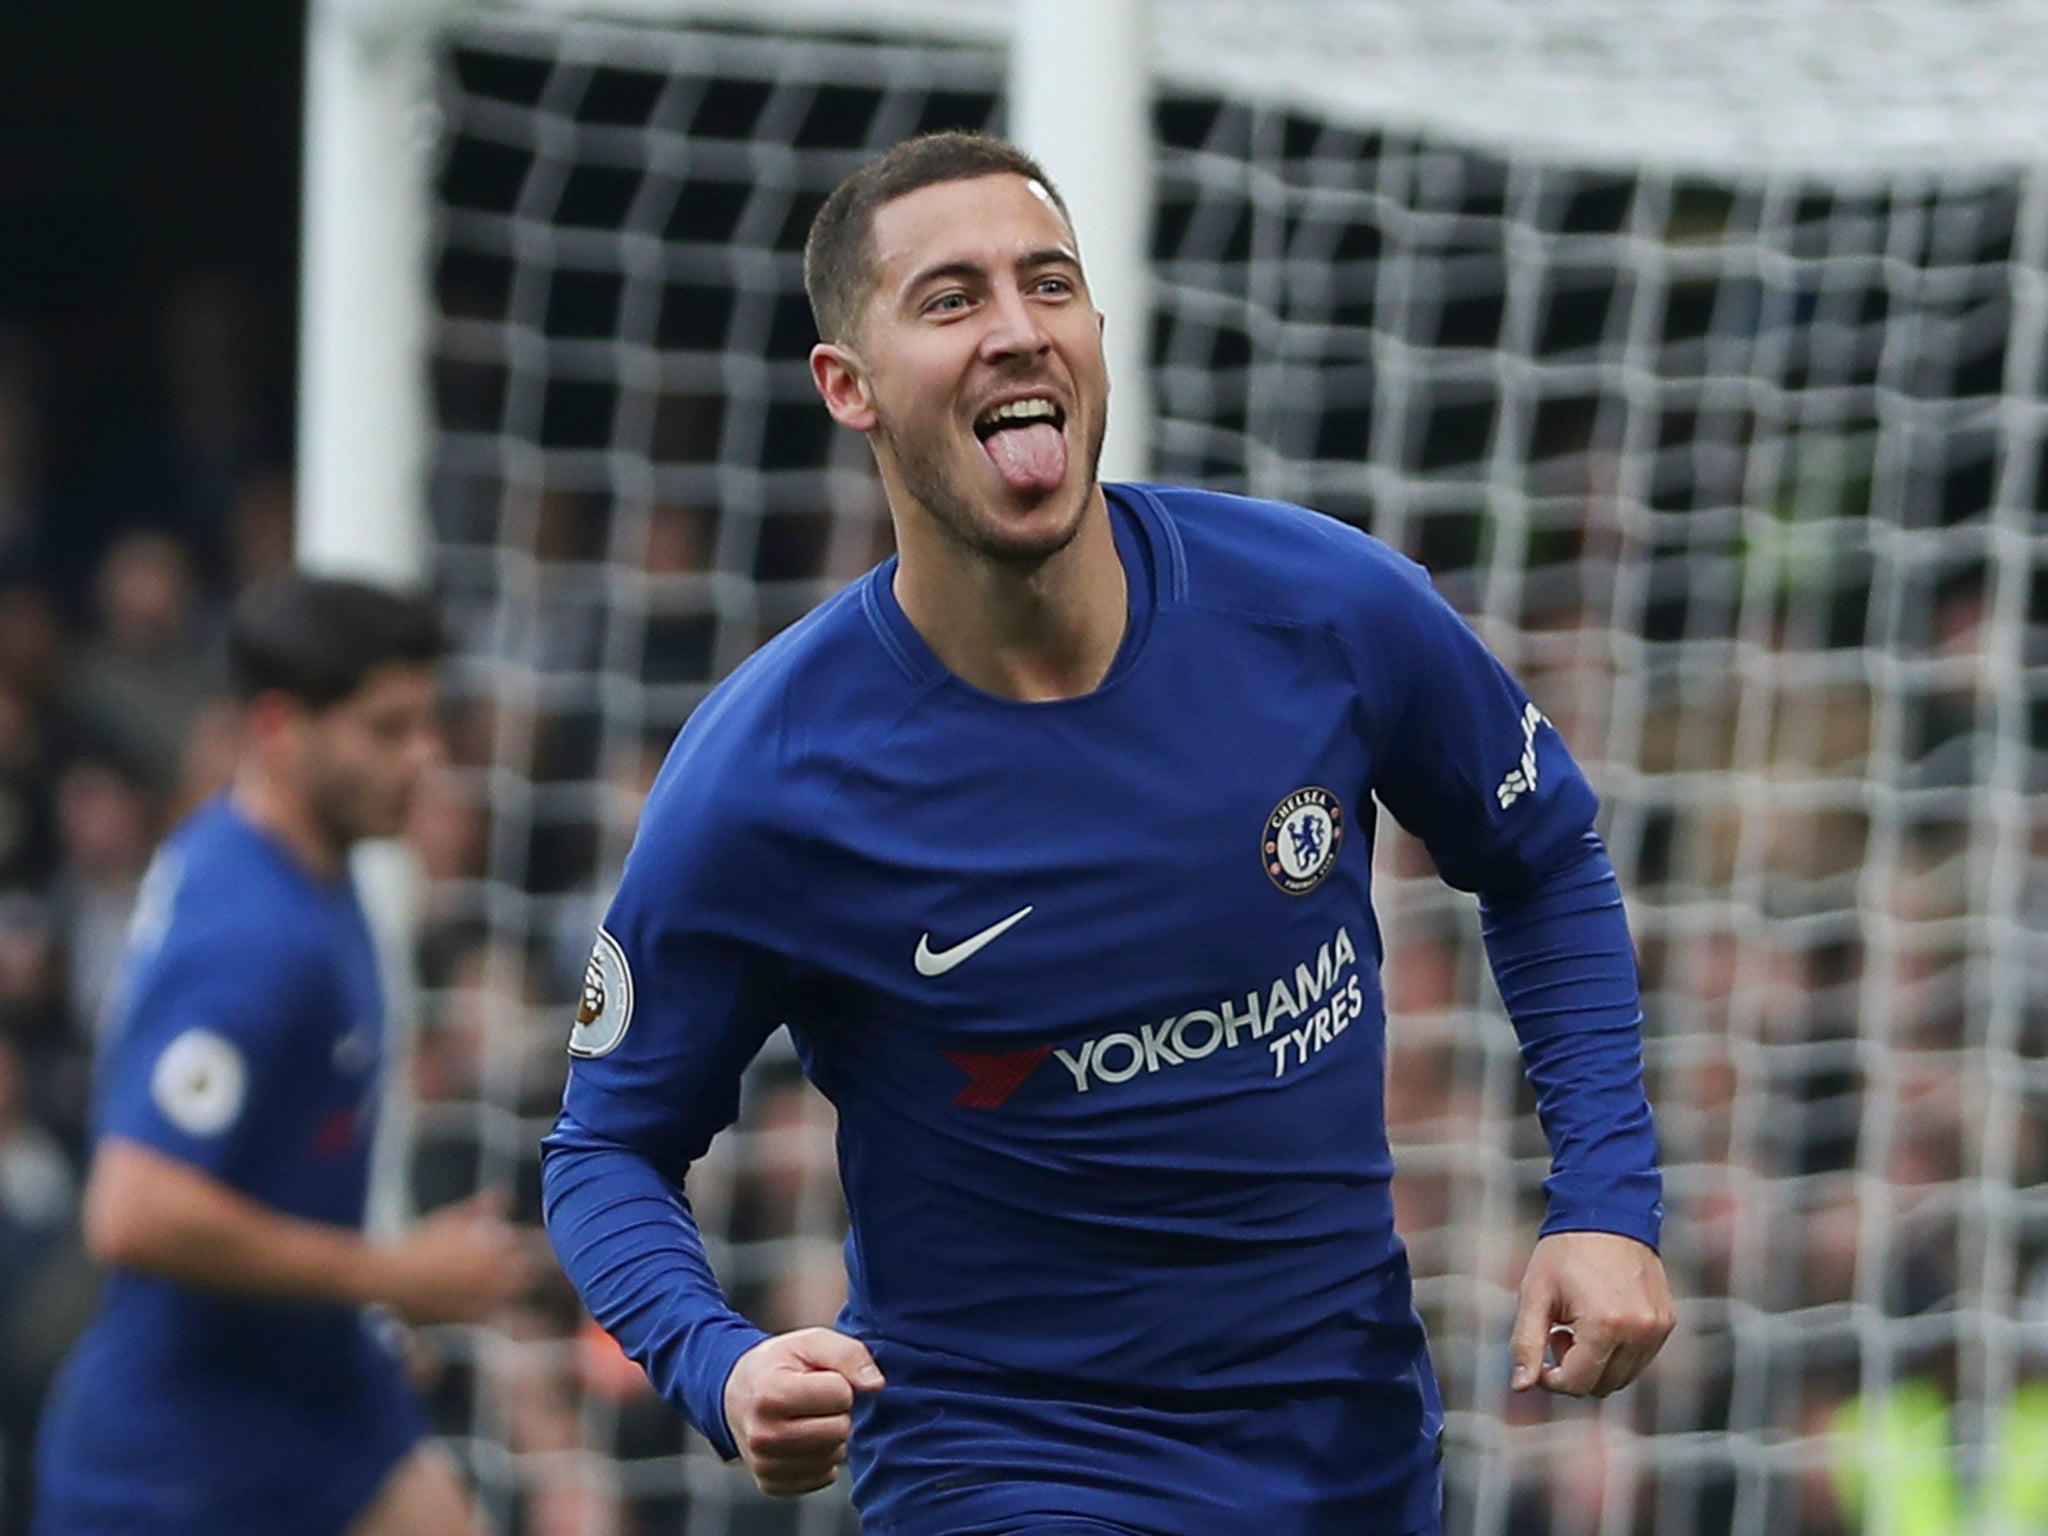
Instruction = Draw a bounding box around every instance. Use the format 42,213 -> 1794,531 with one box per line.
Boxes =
1509,1233 -> 1677,1397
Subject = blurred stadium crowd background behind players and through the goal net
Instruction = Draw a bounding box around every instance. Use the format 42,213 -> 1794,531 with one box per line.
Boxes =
0,0 -> 2048,1536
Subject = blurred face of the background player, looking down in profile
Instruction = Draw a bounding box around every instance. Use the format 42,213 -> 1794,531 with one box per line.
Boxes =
301,662 -> 440,848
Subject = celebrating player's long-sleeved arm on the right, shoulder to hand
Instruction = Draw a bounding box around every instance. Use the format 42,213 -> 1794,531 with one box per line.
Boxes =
1374,548 -> 1675,1395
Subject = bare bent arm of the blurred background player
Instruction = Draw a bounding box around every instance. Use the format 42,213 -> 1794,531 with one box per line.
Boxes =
84,1137 -> 528,1323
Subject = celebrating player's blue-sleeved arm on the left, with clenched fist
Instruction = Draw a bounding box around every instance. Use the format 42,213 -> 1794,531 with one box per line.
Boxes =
541,876 -> 881,1493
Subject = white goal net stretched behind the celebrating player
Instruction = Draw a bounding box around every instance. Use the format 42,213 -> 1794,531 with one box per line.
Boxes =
385,0 -> 2048,1536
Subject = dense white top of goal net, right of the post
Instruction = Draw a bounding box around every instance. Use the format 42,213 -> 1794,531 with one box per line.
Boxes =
1159,0 -> 2048,182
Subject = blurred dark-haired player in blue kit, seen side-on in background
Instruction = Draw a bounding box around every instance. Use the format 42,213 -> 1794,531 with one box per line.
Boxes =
35,578 -> 526,1536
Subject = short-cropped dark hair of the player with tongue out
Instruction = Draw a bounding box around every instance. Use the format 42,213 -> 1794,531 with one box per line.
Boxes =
803,133 -> 1073,342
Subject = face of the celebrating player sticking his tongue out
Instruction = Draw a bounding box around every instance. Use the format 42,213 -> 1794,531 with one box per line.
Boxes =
813,174 -> 1110,563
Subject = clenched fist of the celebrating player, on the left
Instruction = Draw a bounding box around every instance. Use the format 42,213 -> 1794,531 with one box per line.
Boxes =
725,1327 -> 883,1495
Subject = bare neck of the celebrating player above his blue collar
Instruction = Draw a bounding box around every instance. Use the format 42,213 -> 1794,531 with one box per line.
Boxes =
893,489 -> 1130,702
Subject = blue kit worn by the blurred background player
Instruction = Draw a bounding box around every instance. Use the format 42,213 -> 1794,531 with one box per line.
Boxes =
39,797 -> 424,1532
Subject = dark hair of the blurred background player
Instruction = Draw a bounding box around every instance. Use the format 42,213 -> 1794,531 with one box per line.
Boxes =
227,573 -> 449,709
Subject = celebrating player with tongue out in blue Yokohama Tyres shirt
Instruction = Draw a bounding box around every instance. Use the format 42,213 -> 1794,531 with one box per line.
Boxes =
545,135 -> 1673,1536
